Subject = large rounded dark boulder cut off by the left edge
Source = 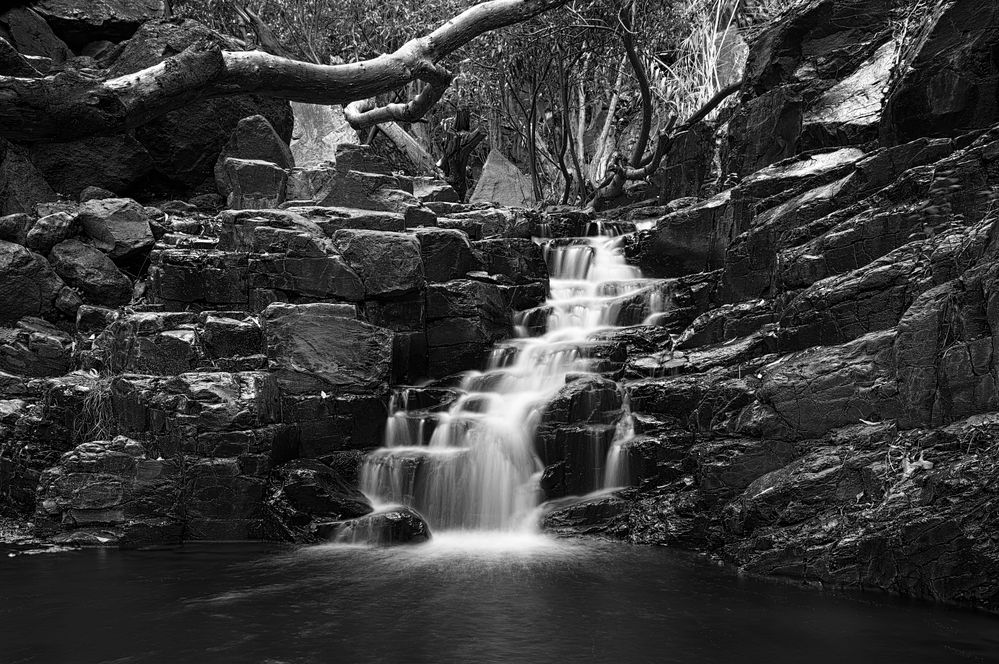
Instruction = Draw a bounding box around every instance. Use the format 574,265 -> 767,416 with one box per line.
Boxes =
0,241 -> 64,322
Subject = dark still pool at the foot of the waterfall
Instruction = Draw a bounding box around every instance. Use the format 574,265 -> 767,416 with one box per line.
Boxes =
0,536 -> 999,664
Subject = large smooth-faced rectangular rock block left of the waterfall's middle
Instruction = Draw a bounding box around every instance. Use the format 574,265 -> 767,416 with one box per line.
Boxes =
261,303 -> 392,393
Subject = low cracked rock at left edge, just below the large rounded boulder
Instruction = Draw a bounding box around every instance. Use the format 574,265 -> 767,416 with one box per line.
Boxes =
0,318 -> 73,377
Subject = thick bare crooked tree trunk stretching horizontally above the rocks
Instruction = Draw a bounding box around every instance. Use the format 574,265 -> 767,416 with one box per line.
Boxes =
0,0 -> 567,142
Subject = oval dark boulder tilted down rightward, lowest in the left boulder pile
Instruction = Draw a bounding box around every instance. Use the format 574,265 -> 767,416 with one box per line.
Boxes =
49,240 -> 132,306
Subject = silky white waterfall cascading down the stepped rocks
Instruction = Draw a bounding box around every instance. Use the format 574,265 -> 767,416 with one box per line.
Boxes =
361,223 -> 662,531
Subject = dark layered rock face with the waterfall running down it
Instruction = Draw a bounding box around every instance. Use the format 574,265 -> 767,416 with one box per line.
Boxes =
0,0 -> 999,611
